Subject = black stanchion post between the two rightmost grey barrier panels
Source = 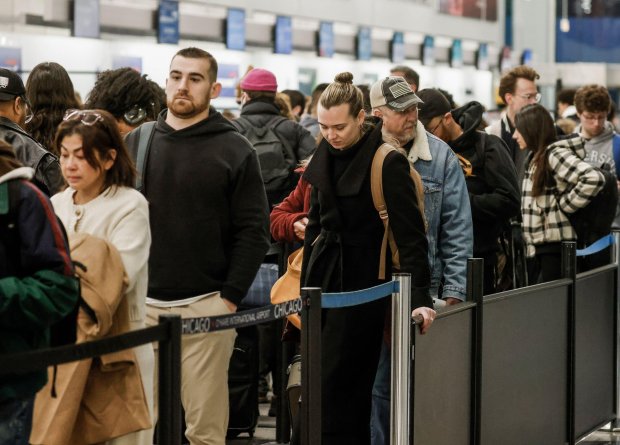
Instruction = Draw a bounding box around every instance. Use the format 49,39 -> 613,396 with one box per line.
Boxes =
560,241 -> 577,444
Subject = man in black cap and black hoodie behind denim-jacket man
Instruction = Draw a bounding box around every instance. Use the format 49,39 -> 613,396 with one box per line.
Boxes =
418,88 -> 520,294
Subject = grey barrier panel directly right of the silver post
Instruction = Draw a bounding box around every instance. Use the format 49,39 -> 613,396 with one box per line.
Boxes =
411,303 -> 476,445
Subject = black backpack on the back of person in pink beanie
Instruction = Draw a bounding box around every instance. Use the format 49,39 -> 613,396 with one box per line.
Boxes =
232,116 -> 298,194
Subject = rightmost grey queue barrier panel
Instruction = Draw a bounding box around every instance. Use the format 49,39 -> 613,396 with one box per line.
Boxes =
574,265 -> 617,440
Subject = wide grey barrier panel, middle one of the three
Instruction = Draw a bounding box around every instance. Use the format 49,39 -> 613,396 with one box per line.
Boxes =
480,279 -> 572,445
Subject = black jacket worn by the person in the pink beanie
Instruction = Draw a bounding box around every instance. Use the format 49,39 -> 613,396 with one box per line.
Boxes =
241,99 -> 316,208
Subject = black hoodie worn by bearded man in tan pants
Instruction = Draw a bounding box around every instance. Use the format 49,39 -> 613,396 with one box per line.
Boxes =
126,108 -> 269,304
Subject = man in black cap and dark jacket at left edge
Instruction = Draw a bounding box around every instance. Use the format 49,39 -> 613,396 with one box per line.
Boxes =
0,68 -> 64,196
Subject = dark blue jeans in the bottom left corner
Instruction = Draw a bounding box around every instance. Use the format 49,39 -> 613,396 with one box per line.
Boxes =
0,396 -> 34,445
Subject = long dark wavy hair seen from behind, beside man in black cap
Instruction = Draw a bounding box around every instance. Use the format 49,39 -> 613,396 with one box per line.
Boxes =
26,62 -> 79,155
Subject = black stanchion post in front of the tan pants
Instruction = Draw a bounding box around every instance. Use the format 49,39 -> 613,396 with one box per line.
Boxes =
157,315 -> 181,445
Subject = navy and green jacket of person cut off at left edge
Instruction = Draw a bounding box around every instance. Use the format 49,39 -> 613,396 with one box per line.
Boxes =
0,144 -> 78,402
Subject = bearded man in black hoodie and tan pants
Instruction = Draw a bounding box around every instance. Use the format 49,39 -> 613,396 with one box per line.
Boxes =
127,48 -> 269,445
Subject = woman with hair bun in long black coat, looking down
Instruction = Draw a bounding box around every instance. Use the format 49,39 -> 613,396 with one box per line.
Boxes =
301,72 -> 435,445
